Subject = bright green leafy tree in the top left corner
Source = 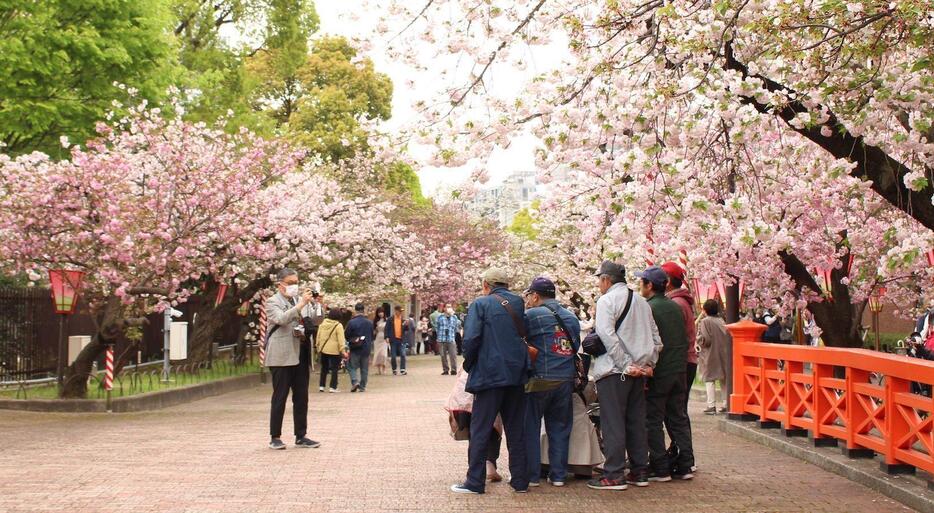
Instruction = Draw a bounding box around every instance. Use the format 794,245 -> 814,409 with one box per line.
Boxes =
0,0 -> 176,156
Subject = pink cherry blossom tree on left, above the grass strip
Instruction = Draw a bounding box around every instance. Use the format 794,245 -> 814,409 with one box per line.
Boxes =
0,103 -> 301,397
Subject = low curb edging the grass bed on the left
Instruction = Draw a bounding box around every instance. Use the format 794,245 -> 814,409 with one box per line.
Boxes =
0,373 -> 260,413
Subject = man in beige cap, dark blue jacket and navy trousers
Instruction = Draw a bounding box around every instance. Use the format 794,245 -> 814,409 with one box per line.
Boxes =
451,268 -> 538,494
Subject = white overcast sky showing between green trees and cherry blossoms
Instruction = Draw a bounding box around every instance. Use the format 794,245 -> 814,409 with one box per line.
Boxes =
315,0 -> 535,196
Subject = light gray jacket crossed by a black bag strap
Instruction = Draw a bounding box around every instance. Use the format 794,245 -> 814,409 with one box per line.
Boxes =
591,283 -> 662,379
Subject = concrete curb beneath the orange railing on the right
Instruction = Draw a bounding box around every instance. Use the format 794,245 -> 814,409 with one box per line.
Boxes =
718,419 -> 934,513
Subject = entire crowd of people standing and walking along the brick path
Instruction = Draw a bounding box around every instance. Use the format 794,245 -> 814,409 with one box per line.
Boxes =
266,261 -> 730,493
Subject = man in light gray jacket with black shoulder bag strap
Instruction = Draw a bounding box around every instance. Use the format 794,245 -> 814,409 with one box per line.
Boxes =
587,260 -> 662,490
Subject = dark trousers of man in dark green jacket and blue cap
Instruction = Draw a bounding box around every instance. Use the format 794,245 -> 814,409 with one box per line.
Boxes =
652,373 -> 694,475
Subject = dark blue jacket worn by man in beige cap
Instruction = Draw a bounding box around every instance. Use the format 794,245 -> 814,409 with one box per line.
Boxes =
463,287 -> 531,393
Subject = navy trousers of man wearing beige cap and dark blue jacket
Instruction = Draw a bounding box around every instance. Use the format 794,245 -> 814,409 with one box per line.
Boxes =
464,385 -> 529,493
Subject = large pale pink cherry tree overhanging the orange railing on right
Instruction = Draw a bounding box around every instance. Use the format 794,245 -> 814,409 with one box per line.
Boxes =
372,0 -> 934,345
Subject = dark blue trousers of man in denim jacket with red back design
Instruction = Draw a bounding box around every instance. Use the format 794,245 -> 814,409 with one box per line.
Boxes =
525,381 -> 574,483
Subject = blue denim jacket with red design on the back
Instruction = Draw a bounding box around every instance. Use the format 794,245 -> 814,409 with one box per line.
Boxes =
525,299 -> 581,379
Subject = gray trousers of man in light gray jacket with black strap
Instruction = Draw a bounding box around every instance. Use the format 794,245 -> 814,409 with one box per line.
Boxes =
597,374 -> 649,479
